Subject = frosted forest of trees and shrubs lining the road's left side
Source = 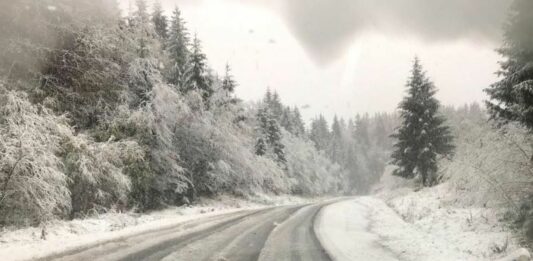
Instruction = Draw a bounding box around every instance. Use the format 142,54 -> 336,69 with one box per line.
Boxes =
0,0 -> 392,226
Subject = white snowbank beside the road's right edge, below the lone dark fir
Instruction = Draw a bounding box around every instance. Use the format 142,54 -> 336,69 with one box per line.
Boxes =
316,197 -> 527,261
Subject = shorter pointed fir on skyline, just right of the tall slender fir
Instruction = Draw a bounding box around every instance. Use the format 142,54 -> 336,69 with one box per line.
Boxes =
186,36 -> 214,105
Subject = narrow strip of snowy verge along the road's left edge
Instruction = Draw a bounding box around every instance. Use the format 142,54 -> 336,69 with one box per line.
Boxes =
0,195 -> 309,261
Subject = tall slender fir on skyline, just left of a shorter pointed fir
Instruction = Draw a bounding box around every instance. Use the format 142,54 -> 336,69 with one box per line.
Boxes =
166,7 -> 190,88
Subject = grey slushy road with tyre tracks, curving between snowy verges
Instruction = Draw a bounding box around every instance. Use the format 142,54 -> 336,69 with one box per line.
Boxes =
42,202 -> 331,261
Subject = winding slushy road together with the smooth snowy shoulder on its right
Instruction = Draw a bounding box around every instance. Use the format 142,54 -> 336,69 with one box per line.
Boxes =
34,198 -> 408,261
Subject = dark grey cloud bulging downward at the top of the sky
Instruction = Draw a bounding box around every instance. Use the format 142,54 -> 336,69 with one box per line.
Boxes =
274,0 -> 511,64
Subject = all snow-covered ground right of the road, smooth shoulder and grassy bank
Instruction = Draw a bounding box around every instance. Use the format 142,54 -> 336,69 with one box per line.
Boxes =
316,162 -> 529,261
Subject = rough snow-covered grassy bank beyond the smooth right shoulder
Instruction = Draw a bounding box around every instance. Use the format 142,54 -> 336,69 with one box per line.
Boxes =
372,183 -> 519,260
